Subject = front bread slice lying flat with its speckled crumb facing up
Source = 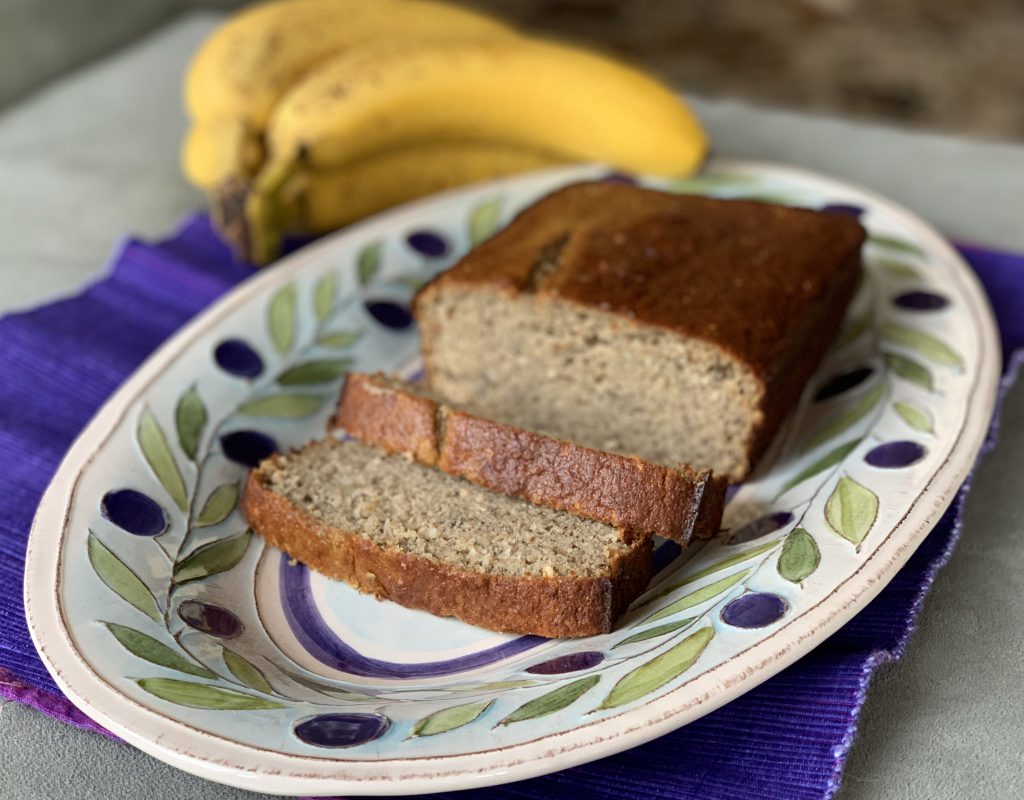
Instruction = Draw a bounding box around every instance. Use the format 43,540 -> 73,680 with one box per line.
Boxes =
242,438 -> 651,636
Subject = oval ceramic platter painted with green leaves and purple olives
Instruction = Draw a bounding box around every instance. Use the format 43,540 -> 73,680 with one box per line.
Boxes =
26,162 -> 999,795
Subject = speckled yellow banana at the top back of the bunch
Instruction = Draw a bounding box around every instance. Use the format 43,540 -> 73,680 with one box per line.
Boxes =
185,0 -> 512,129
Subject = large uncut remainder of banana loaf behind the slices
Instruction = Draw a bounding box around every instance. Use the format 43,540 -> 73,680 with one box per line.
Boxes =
415,182 -> 864,480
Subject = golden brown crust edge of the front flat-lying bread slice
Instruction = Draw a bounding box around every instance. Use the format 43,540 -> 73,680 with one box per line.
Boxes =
242,457 -> 651,637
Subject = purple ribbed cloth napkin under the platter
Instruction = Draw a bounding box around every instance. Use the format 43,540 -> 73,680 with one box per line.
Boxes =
0,216 -> 1024,800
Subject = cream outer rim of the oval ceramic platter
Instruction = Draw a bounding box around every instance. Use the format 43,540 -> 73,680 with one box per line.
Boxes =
24,159 -> 1000,795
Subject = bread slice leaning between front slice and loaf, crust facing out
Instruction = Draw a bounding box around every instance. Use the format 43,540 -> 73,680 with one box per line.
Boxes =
331,373 -> 726,544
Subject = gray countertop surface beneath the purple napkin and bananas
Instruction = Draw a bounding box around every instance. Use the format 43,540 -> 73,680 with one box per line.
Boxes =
0,13 -> 1024,800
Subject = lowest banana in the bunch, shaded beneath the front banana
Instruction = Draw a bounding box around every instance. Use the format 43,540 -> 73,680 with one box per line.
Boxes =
240,141 -> 564,263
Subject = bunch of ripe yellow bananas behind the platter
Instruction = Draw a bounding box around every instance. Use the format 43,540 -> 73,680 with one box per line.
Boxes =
183,0 -> 707,263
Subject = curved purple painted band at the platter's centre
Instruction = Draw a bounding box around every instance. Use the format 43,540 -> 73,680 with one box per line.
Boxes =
280,554 -> 550,678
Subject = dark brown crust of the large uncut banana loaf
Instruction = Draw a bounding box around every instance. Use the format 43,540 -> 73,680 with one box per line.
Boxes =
414,181 -> 865,480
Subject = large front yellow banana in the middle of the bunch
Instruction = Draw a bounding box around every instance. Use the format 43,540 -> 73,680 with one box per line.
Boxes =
267,38 -> 707,175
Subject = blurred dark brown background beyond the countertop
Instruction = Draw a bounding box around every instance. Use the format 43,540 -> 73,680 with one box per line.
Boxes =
0,0 -> 1024,139
